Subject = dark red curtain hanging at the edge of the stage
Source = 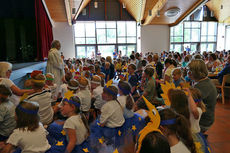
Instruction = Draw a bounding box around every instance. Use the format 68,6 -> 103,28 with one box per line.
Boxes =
35,0 -> 53,61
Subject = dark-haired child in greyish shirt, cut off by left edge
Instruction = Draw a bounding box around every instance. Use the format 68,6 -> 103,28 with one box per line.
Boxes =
0,85 -> 16,142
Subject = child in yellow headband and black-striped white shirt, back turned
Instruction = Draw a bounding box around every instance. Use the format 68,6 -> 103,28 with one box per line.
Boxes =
26,73 -> 54,125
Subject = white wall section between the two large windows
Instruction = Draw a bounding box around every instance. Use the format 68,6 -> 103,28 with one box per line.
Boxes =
141,25 -> 170,53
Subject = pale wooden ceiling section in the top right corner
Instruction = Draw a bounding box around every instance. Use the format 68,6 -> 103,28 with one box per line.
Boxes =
206,0 -> 230,24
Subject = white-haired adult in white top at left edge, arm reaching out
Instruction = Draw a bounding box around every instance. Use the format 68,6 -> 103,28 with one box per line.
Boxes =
0,62 -> 33,105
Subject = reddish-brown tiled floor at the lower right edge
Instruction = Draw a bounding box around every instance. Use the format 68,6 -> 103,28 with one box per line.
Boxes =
207,98 -> 230,153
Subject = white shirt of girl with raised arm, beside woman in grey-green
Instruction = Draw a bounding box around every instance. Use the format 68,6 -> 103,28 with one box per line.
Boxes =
190,107 -> 202,133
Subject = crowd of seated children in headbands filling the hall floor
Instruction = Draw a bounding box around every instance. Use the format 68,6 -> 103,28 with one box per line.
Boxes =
0,49 -> 230,153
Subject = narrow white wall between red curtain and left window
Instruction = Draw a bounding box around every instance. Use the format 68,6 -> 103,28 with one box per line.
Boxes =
53,22 -> 75,59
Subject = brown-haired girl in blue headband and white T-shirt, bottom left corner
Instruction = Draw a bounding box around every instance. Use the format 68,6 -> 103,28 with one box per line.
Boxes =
2,101 -> 50,153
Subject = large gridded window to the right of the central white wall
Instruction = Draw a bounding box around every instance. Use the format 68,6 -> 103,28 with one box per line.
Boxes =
170,21 -> 217,52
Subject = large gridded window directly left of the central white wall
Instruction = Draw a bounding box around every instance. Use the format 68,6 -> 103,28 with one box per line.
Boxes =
74,21 -> 137,58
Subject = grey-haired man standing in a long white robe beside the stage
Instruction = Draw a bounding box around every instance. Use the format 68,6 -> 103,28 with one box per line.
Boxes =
46,40 -> 64,86
